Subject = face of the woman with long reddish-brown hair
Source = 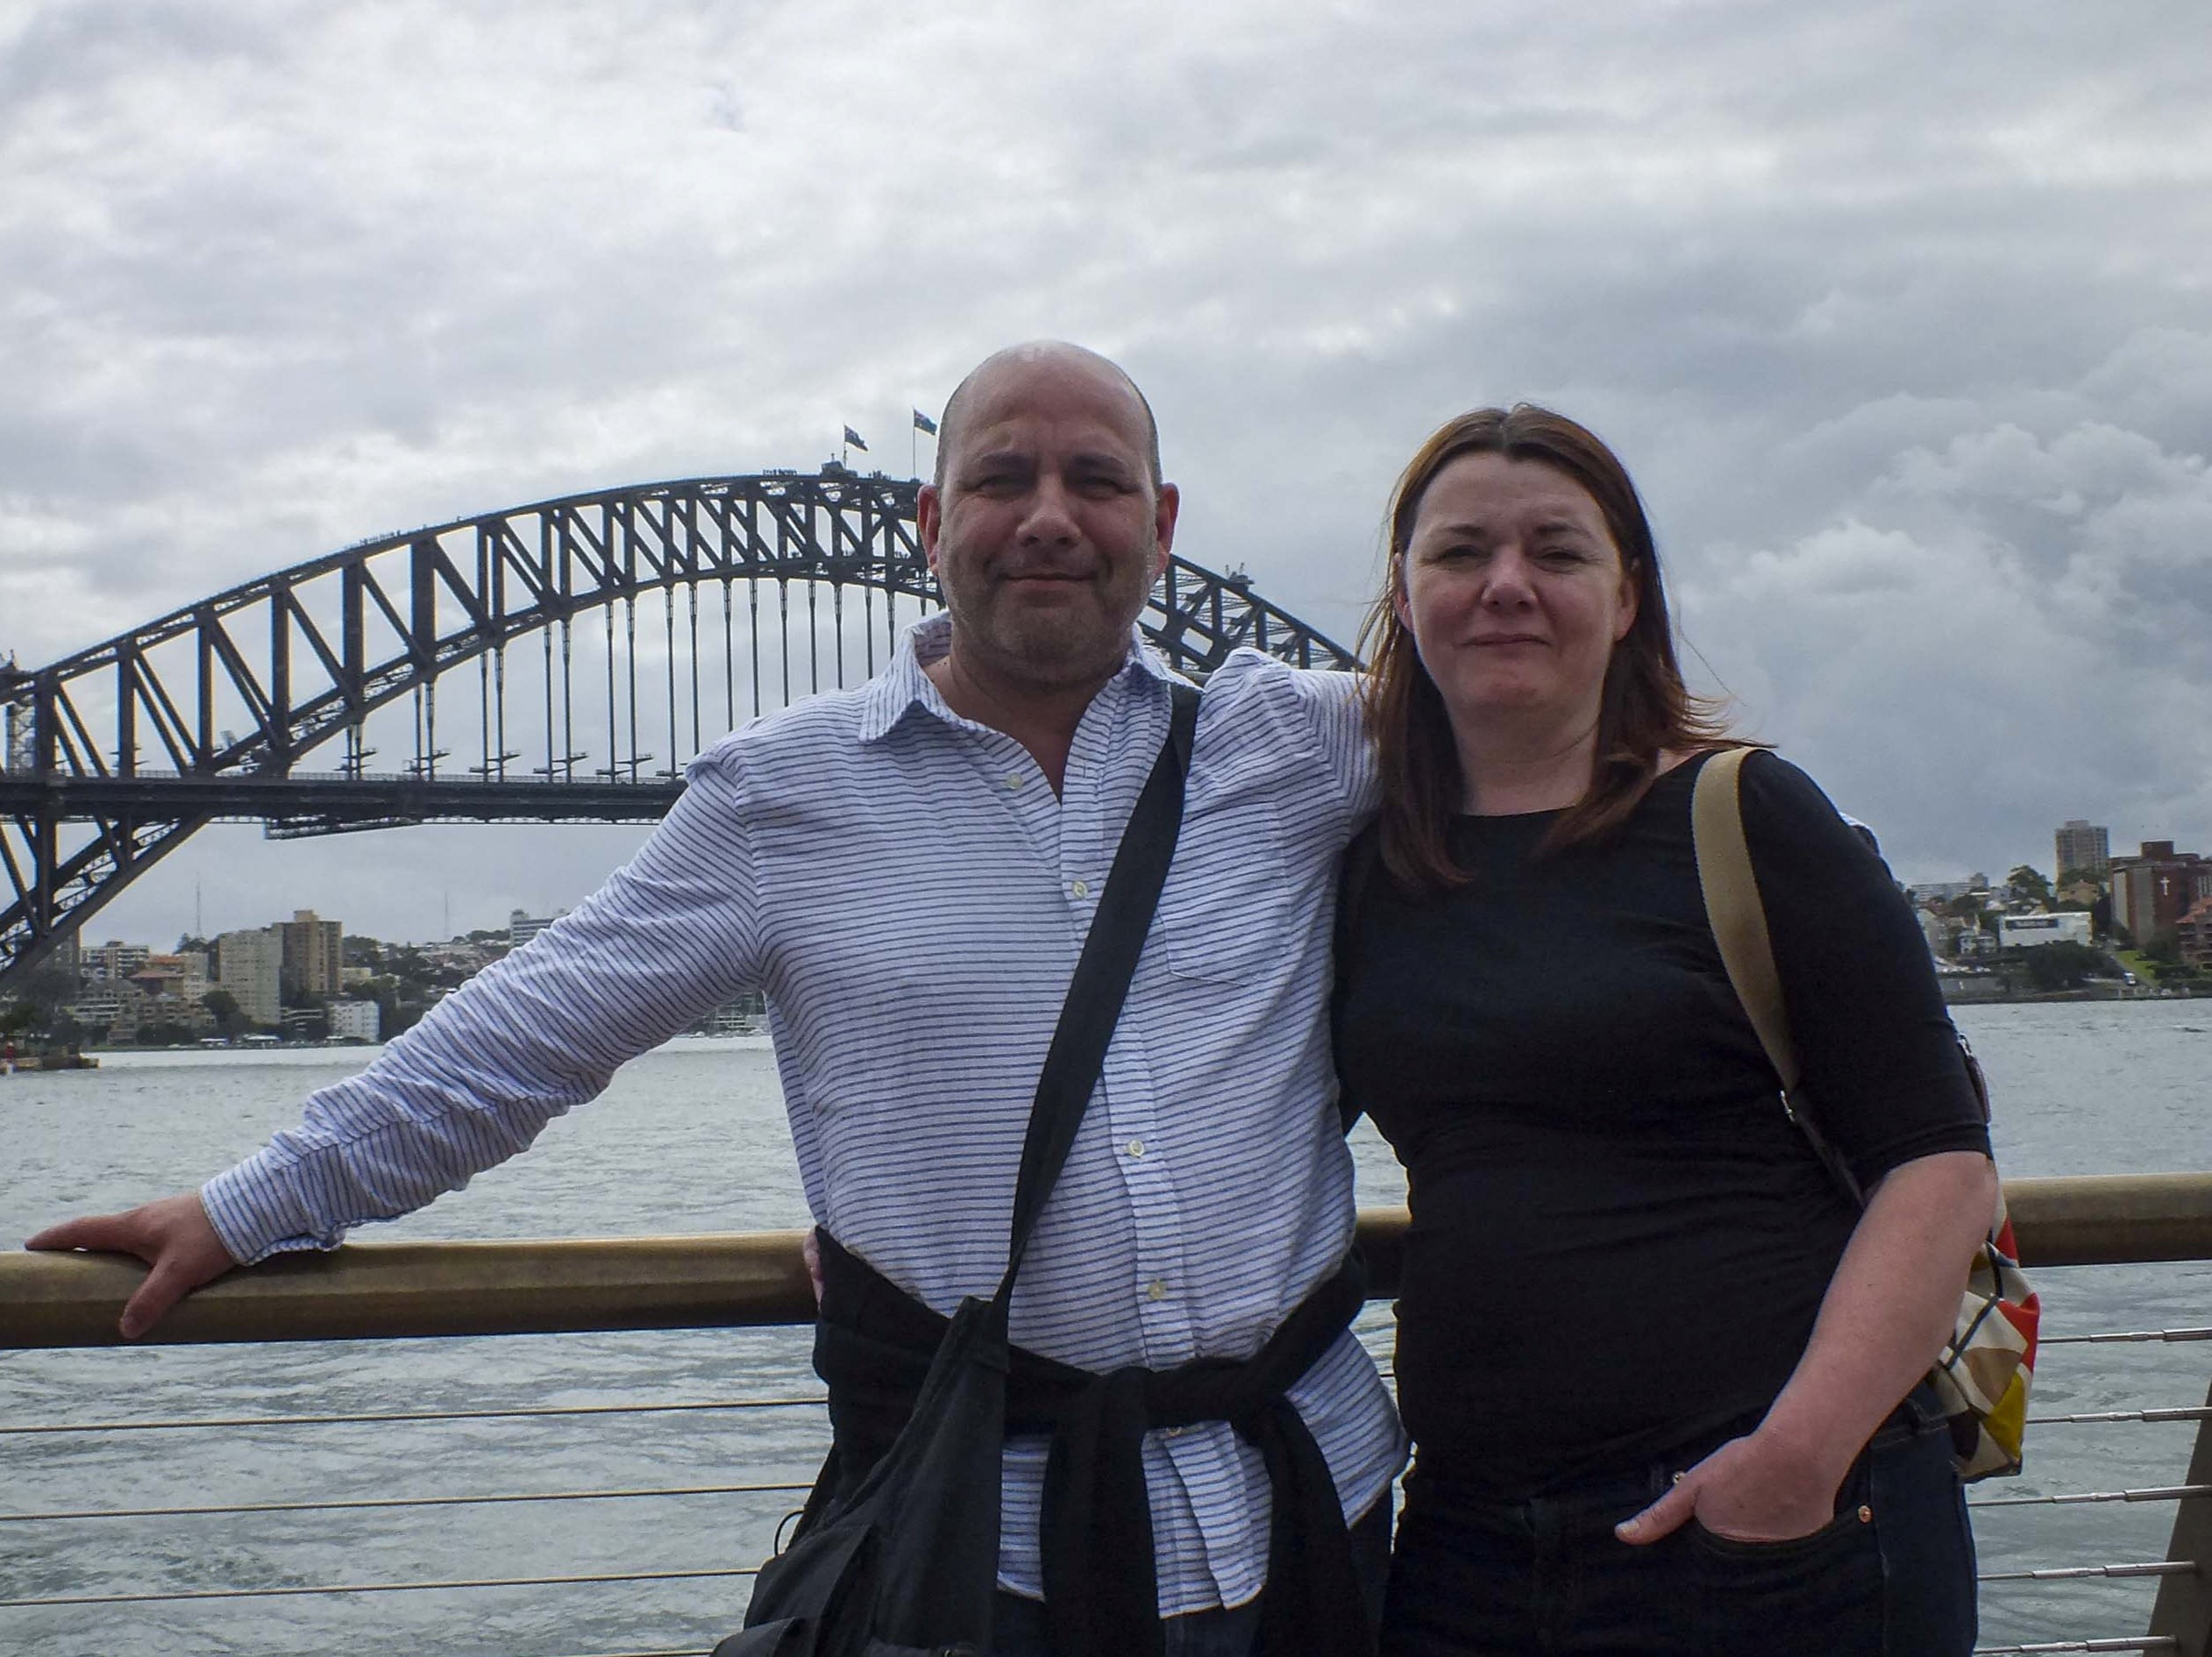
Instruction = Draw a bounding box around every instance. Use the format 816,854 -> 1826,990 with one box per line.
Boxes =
1398,453 -> 1637,732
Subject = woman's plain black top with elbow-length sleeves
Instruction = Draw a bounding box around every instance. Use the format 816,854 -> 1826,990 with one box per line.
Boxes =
1336,752 -> 1988,1500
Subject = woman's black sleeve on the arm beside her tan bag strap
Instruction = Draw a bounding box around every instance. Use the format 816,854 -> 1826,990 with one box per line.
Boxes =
1743,752 -> 1988,1188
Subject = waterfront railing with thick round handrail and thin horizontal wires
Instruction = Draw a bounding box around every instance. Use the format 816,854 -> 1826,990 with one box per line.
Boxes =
0,1172 -> 2212,1657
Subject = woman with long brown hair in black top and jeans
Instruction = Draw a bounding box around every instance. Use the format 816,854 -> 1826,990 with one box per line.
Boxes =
1336,405 -> 1995,1657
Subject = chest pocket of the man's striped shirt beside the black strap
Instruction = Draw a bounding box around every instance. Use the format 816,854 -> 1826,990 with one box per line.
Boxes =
1159,794 -> 1312,985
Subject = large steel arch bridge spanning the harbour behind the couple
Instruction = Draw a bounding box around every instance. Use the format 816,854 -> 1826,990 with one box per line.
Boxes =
0,462 -> 1358,993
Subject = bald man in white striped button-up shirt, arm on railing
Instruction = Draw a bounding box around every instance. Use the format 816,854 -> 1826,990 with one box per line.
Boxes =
31,343 -> 1403,1657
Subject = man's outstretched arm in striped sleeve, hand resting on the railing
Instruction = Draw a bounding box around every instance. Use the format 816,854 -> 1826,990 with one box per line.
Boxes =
29,757 -> 763,1339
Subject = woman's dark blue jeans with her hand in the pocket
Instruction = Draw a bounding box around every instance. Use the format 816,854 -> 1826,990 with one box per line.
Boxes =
1383,1390 -> 1975,1657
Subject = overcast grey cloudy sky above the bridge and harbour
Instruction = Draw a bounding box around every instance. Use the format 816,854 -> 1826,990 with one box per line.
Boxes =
0,0 -> 2212,940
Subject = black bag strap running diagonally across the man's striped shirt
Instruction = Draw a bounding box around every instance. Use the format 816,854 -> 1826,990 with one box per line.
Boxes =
993,684 -> 1198,1307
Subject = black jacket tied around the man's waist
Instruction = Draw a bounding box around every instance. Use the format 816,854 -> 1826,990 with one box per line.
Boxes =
807,1233 -> 1374,1657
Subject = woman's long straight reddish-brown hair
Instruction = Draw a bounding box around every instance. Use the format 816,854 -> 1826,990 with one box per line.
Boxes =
1361,402 -> 1725,892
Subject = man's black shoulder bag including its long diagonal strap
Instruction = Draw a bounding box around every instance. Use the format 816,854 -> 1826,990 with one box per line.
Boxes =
715,686 -> 1198,1657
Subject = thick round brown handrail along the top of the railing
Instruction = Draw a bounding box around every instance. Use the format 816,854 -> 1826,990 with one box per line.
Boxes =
12,1172 -> 2212,1349
